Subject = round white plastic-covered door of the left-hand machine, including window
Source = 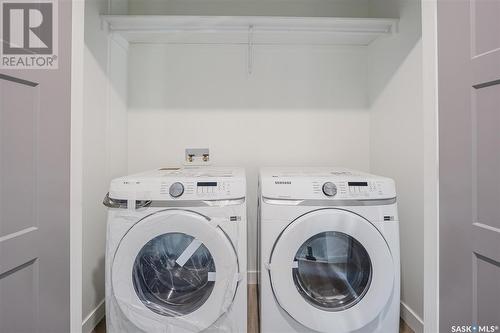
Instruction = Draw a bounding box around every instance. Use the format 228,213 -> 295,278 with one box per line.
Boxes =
111,210 -> 238,332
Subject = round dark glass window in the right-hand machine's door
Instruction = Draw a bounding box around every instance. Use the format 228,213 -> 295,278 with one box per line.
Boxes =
292,231 -> 372,311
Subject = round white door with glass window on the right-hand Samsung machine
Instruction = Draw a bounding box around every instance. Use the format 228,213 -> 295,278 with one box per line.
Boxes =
269,209 -> 394,332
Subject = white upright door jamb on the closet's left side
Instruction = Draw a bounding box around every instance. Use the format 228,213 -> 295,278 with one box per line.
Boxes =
70,0 -> 85,333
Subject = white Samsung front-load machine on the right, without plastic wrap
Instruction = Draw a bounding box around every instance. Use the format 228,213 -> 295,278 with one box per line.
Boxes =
259,168 -> 400,333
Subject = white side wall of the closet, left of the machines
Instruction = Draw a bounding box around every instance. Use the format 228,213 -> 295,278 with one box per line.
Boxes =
82,0 -> 127,332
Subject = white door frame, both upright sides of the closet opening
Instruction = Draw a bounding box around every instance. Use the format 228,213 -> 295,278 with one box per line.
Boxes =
66,0 -> 439,333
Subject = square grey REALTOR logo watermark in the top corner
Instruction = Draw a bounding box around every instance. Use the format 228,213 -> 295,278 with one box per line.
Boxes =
0,0 -> 58,69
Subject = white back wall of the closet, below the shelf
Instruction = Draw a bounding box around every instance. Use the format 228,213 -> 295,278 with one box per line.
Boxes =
128,44 -> 369,271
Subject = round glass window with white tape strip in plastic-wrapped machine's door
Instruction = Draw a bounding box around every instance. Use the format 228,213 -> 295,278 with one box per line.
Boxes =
132,233 -> 215,317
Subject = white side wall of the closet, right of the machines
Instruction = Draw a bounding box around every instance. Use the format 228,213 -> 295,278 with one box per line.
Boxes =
368,0 -> 424,332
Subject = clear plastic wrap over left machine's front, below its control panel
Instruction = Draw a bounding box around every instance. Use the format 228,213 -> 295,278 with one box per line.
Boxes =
106,201 -> 246,333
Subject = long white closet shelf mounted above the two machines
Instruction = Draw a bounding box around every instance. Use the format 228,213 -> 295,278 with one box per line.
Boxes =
101,15 -> 399,45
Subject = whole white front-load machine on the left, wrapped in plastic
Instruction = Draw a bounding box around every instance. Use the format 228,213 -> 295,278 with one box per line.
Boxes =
104,167 -> 247,333
